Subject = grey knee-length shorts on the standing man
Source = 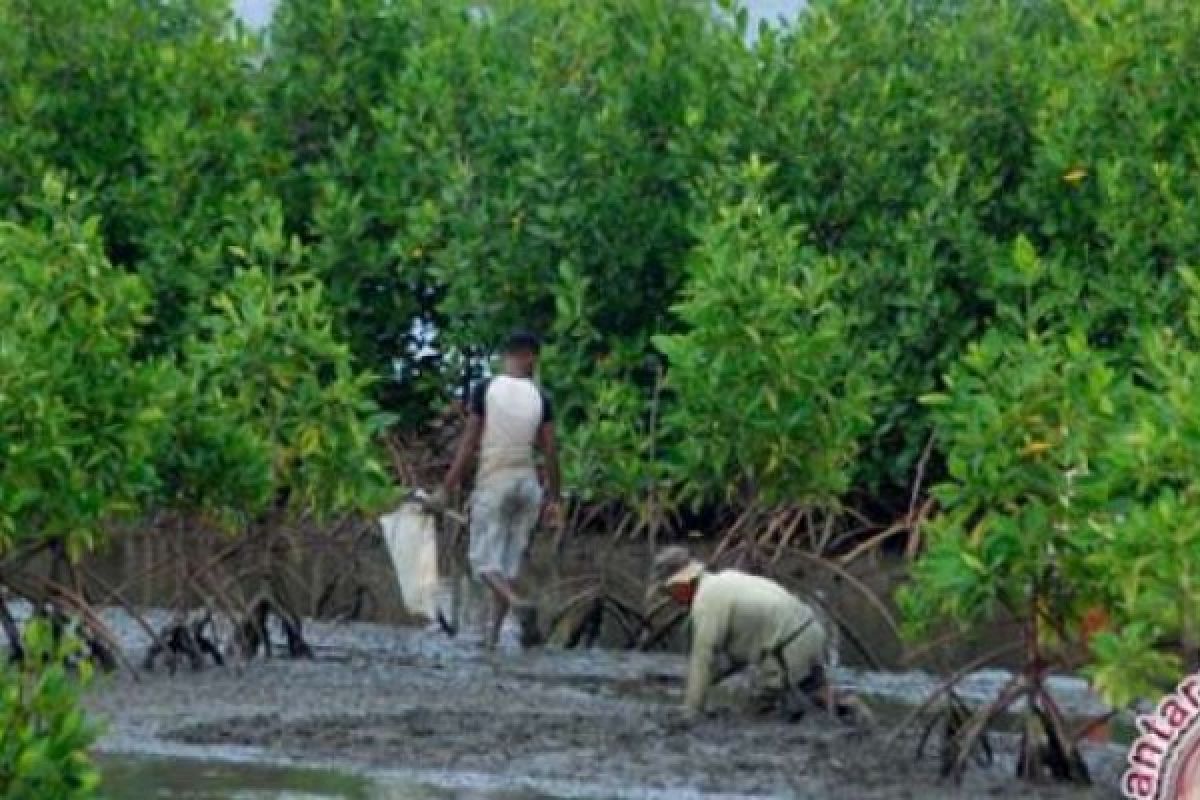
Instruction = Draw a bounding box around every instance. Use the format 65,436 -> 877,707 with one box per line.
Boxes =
467,471 -> 541,581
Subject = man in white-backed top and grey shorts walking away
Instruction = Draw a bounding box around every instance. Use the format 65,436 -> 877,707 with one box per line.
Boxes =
439,331 -> 559,649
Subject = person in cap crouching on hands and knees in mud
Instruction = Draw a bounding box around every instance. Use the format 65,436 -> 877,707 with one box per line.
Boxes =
654,547 -> 870,723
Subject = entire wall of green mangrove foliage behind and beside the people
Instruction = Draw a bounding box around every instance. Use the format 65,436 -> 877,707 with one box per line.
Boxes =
0,0 -> 1200,782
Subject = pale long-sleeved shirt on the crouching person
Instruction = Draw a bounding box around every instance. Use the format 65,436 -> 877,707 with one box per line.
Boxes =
685,570 -> 826,711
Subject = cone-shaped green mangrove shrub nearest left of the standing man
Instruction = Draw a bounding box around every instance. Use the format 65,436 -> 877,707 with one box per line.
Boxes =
163,221 -> 390,523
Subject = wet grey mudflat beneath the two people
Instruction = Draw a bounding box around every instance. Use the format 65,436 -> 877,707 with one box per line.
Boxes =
89,624 -> 1121,800
